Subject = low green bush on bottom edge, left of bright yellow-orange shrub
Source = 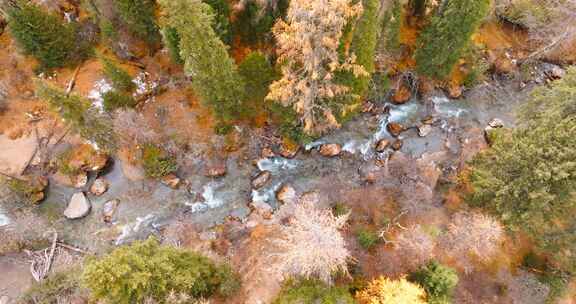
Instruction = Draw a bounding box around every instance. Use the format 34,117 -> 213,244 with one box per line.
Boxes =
273,280 -> 355,304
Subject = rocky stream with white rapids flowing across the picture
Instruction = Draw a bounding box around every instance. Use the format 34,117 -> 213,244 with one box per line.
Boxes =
27,79 -> 524,249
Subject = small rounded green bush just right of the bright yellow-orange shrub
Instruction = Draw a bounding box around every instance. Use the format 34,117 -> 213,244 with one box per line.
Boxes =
409,261 -> 458,304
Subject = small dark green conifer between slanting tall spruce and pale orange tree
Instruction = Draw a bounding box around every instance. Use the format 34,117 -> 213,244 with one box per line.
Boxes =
238,52 -> 277,117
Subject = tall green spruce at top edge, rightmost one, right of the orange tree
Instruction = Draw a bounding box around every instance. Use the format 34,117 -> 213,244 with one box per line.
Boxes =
415,0 -> 490,79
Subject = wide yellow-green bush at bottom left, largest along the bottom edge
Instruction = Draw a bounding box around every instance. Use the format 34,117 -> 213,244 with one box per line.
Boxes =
81,238 -> 235,304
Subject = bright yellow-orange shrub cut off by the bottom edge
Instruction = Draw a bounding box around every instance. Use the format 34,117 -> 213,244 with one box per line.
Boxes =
356,277 -> 427,304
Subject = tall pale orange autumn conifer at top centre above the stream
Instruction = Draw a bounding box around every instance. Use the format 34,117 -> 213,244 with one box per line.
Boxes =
267,0 -> 367,135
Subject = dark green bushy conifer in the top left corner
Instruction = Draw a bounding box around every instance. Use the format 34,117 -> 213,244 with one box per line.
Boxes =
6,1 -> 89,69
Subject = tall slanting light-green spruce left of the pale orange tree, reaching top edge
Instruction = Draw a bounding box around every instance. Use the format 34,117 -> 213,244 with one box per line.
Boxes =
159,0 -> 244,131
